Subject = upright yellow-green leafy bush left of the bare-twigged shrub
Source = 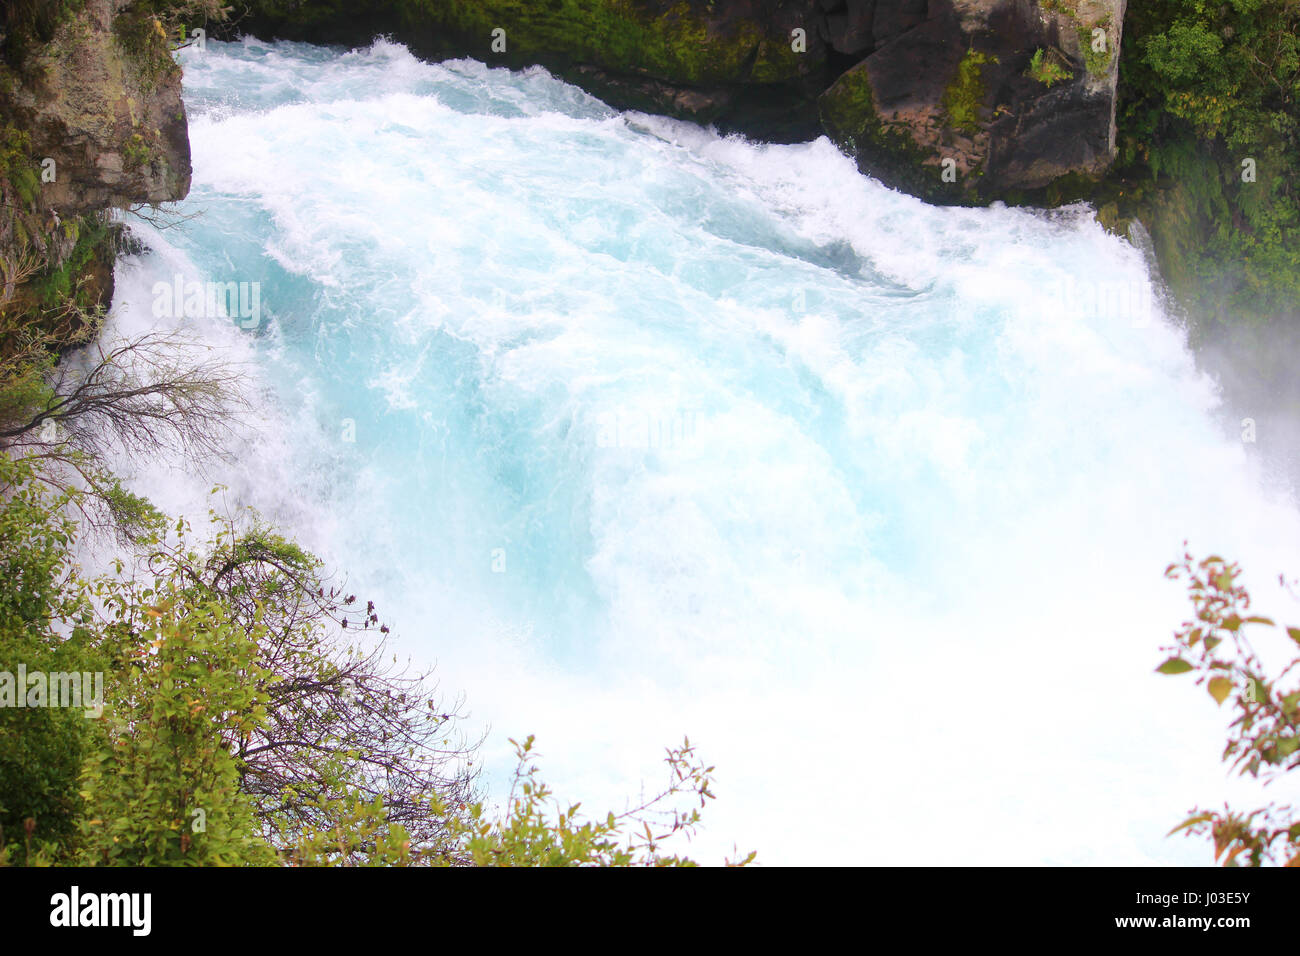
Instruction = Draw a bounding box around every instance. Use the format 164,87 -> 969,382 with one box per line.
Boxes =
75,567 -> 276,866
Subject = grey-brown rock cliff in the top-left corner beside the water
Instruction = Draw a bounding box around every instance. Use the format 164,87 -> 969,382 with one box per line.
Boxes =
0,0 -> 191,321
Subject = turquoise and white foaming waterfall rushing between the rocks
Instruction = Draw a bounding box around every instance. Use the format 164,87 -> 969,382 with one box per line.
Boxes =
104,40 -> 1300,864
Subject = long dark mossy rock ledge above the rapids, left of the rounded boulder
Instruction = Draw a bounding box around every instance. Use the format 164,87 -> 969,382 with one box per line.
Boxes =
230,0 -> 832,140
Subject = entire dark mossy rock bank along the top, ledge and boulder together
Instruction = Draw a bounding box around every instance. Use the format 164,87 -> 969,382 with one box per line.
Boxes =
235,0 -> 1125,202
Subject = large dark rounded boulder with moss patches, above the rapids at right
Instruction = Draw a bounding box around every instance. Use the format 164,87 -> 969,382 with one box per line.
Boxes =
819,0 -> 1125,202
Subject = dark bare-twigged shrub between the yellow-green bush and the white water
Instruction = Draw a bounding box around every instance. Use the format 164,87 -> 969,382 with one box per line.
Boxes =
133,512 -> 477,852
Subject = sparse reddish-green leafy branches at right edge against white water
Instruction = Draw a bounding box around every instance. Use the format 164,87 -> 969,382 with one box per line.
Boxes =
1157,554 -> 1300,866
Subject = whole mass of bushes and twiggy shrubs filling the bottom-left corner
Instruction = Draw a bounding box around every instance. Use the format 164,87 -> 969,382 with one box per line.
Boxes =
0,444 -> 753,866
